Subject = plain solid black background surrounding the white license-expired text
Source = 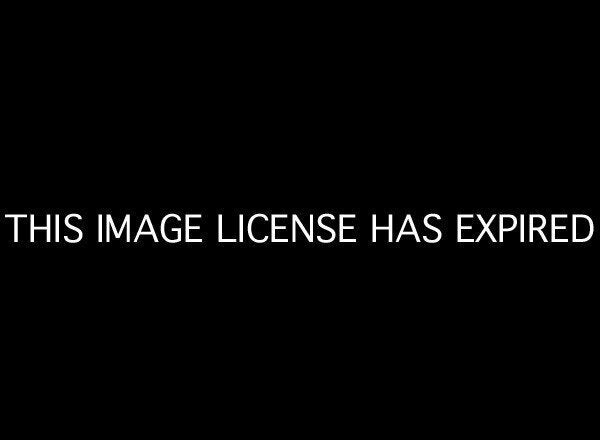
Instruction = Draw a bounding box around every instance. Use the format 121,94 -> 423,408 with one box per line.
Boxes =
1,5 -> 598,433
